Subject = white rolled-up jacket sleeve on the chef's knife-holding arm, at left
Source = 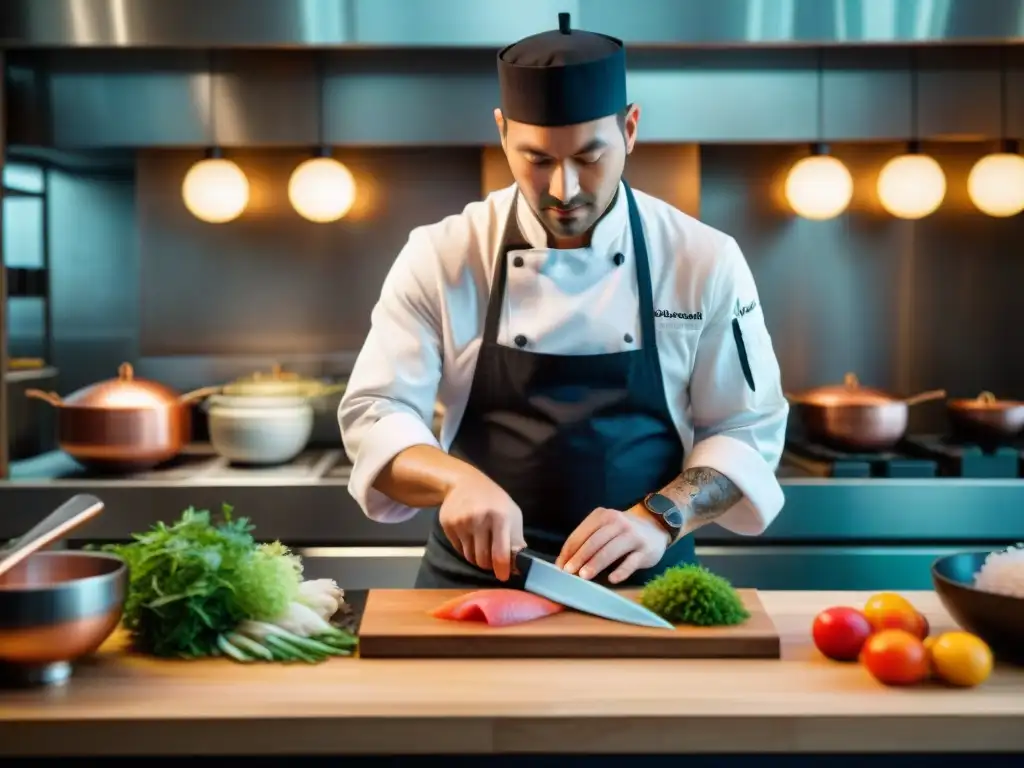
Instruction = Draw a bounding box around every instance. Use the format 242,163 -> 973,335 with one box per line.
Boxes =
338,229 -> 442,522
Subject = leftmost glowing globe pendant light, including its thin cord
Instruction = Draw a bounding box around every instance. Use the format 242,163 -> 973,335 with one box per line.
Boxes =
181,50 -> 249,224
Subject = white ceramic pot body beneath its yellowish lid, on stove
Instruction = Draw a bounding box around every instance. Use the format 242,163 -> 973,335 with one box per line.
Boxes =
206,395 -> 313,464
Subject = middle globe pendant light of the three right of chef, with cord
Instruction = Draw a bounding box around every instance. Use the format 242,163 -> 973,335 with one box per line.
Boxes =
878,50 -> 946,219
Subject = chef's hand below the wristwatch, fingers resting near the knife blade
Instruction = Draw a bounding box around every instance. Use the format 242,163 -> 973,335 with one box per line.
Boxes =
555,507 -> 671,584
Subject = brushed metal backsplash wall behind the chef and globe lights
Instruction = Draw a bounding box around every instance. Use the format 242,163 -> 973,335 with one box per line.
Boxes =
11,142 -> 1024,421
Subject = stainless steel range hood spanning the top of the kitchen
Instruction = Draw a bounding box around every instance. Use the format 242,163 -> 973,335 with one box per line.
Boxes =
0,0 -> 1024,152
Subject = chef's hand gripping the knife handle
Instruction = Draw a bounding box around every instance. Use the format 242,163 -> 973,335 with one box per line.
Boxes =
438,469 -> 526,582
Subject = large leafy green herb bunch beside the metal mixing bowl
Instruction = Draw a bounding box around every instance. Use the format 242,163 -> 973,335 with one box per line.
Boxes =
103,505 -> 302,658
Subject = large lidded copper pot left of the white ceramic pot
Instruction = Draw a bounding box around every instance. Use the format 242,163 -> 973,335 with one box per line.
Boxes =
26,362 -> 217,471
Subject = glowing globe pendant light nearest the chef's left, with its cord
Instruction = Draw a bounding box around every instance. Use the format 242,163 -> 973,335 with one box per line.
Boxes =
288,53 -> 355,224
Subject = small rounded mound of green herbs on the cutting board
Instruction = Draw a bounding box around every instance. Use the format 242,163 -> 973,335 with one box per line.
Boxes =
640,565 -> 751,627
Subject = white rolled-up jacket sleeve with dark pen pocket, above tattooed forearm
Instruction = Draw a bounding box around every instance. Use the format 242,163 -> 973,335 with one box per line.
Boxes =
685,239 -> 790,536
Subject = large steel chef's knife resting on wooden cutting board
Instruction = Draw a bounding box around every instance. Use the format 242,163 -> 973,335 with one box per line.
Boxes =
514,550 -> 676,630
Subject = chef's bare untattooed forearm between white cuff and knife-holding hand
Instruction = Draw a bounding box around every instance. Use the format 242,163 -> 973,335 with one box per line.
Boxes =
374,445 -> 479,508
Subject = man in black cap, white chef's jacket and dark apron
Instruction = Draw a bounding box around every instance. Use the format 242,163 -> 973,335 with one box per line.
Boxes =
338,13 -> 788,588
